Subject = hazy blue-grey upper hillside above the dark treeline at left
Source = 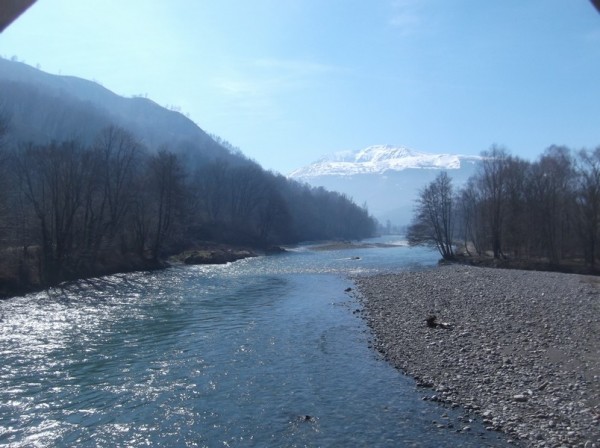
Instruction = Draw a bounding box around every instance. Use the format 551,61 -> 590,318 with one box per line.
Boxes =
0,58 -> 229,164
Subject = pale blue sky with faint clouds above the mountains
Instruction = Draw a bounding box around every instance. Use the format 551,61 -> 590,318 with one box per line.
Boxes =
0,0 -> 600,174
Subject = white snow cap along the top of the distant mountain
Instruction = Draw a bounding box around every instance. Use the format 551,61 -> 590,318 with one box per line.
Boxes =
289,145 -> 479,179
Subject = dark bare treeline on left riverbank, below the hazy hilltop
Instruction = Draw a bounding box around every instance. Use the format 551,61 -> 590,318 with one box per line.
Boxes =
0,124 -> 375,295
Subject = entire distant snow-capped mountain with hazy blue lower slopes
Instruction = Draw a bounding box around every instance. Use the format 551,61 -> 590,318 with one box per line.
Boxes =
289,145 -> 481,225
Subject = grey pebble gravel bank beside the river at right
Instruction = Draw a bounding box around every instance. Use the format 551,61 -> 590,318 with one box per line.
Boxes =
355,265 -> 600,448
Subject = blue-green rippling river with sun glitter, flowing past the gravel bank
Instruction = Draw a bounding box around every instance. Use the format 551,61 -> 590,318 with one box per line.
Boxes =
0,236 -> 506,447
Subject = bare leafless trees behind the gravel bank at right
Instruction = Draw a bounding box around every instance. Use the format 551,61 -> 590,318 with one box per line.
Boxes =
408,146 -> 600,271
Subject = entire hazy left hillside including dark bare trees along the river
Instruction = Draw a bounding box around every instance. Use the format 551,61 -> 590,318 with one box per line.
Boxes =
0,59 -> 376,296
